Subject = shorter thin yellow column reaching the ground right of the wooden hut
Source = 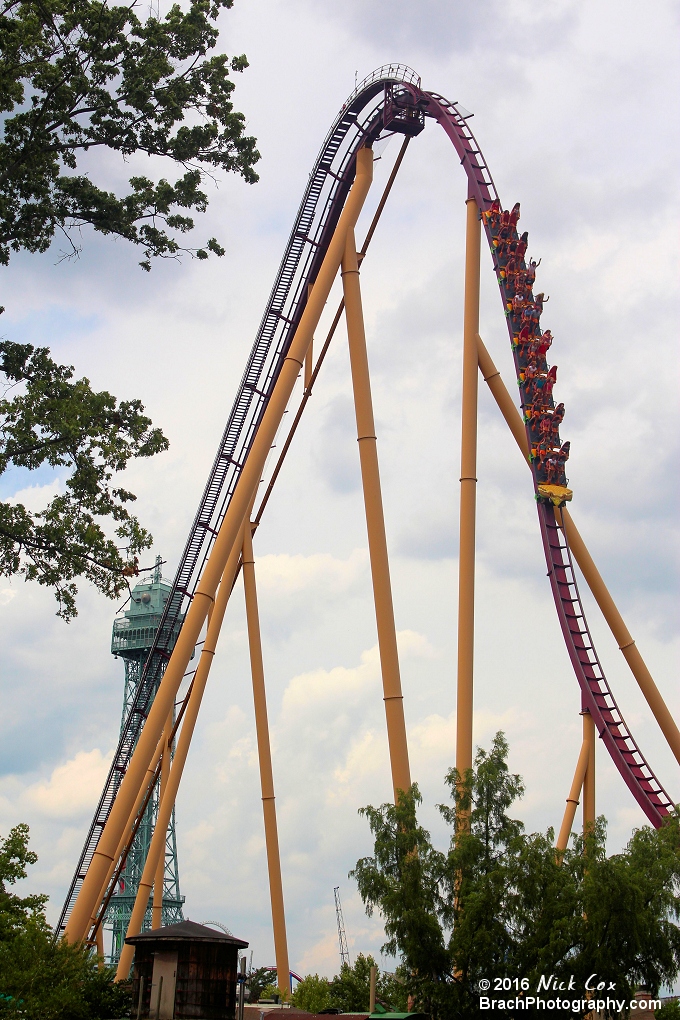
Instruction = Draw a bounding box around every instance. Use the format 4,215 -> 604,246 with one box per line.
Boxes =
244,525 -> 291,992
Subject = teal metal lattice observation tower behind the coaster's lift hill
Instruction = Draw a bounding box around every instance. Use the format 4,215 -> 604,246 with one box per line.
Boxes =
104,556 -> 185,963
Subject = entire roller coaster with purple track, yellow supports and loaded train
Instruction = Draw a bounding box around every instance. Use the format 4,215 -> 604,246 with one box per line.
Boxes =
54,64 -> 680,988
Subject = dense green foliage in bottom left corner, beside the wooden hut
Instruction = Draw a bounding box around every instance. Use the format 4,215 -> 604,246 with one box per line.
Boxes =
0,824 -> 132,1020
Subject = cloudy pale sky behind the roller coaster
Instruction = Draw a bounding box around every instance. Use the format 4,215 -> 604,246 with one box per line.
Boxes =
0,0 -> 680,974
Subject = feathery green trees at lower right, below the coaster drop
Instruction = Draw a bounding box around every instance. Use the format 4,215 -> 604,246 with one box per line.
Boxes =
353,733 -> 680,1018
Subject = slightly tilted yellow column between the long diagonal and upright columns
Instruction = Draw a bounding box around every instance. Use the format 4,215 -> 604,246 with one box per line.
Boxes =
343,230 -> 411,803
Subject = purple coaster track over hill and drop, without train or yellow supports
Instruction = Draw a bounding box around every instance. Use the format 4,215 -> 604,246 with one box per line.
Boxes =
57,64 -> 673,930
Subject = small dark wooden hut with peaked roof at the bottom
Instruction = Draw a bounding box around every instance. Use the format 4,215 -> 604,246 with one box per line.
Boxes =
125,921 -> 248,1020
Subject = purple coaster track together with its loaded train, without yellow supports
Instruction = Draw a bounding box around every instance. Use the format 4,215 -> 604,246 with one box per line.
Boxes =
57,64 -> 673,930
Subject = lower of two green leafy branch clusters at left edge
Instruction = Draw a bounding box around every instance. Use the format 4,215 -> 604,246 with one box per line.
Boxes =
0,342 -> 167,620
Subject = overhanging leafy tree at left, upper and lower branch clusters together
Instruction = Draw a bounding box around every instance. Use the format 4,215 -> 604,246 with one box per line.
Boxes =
0,0 -> 259,607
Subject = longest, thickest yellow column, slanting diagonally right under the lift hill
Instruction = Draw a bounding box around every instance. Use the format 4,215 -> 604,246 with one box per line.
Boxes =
64,149 -> 373,942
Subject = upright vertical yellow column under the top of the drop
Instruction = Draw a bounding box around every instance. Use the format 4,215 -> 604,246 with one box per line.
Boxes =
456,198 -> 481,803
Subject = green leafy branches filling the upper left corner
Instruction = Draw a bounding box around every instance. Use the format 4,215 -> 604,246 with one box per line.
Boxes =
0,0 -> 259,269
